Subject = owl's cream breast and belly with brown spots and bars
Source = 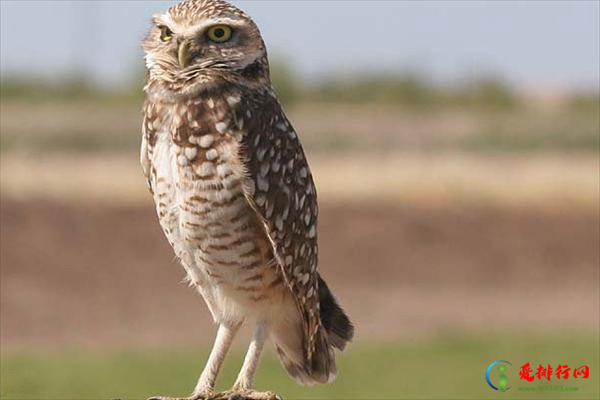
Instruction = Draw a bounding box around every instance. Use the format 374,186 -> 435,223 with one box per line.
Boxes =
142,83 -> 295,321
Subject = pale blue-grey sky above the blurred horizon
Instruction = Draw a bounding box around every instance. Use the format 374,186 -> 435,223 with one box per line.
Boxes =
0,0 -> 600,90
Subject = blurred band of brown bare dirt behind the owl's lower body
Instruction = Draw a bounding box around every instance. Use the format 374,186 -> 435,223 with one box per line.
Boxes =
0,199 -> 600,348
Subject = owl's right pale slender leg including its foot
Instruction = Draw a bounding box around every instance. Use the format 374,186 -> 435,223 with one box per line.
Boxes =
211,323 -> 281,400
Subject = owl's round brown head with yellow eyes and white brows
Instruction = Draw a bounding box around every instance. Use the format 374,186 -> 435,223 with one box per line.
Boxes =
144,0 -> 269,94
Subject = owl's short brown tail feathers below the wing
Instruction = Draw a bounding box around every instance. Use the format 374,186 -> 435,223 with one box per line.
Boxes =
271,276 -> 354,385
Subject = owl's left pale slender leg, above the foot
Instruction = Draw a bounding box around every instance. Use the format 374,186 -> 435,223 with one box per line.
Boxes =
194,323 -> 241,395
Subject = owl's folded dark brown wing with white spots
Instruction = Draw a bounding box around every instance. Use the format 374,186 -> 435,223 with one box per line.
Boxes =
240,93 -> 320,361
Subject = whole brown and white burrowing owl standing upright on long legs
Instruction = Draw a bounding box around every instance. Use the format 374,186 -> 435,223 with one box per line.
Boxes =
141,0 -> 353,399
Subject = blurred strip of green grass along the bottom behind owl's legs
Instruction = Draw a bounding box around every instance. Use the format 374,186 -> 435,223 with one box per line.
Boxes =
0,333 -> 600,399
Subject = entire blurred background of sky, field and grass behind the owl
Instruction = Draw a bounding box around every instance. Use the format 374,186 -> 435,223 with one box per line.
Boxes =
0,0 -> 600,399
